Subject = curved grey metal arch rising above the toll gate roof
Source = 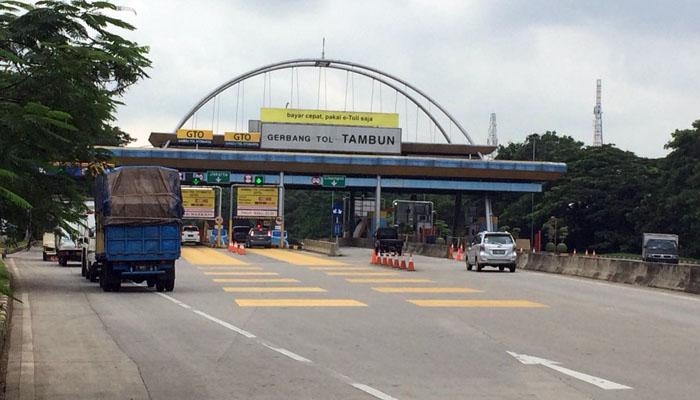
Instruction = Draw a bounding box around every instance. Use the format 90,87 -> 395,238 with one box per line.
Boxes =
173,58 -> 474,144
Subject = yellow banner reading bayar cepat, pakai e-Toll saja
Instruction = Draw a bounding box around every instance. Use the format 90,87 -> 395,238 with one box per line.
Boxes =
260,108 -> 399,128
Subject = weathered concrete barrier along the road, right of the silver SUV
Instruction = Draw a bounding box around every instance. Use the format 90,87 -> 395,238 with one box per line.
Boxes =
518,253 -> 700,294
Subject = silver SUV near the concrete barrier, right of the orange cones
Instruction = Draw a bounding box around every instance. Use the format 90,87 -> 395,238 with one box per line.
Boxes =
467,232 -> 518,272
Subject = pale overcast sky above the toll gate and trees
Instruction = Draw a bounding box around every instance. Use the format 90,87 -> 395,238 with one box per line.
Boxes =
112,0 -> 700,157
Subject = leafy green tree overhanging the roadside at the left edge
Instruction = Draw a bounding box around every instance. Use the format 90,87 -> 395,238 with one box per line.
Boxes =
0,1 -> 150,241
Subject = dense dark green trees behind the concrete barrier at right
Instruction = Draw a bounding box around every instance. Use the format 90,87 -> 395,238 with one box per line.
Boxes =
496,121 -> 700,257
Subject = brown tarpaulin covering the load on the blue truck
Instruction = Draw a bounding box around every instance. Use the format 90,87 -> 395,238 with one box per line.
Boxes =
95,167 -> 183,225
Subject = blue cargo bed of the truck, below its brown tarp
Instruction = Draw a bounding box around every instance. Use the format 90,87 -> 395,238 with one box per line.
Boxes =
104,222 -> 180,262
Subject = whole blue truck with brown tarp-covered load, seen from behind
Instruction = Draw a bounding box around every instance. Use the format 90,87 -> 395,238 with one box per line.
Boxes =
86,167 -> 184,292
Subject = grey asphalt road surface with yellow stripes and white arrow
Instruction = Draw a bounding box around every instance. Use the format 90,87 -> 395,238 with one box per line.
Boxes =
6,247 -> 700,400
